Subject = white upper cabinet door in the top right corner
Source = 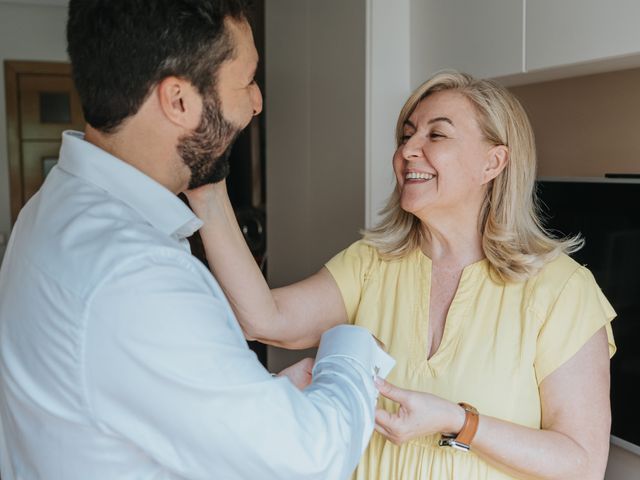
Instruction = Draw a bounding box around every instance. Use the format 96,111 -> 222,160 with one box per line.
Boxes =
525,0 -> 640,71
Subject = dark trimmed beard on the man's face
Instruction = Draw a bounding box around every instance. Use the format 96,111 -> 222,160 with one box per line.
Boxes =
177,95 -> 242,190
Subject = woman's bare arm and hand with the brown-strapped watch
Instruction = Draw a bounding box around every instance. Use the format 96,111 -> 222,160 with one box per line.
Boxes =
376,328 -> 611,480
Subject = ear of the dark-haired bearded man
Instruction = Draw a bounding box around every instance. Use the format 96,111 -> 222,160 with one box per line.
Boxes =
156,76 -> 202,130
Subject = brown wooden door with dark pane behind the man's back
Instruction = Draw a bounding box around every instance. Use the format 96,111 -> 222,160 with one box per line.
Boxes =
4,60 -> 84,222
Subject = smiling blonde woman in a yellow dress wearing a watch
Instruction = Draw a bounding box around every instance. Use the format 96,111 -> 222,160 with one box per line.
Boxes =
190,73 -> 615,480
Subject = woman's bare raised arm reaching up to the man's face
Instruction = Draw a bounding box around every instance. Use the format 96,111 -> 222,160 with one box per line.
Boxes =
187,181 -> 347,348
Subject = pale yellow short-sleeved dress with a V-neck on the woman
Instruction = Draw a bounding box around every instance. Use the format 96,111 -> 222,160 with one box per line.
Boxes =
326,241 -> 615,480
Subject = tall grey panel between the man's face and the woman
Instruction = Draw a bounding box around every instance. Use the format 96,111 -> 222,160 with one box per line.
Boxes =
265,0 -> 365,371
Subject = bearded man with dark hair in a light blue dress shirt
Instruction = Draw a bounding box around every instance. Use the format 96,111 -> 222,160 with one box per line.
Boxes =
0,0 -> 388,480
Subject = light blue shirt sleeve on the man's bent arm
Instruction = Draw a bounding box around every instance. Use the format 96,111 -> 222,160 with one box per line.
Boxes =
84,251 -> 377,480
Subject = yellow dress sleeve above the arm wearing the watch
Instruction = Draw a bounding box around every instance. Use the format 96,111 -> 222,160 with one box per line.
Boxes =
535,267 -> 616,385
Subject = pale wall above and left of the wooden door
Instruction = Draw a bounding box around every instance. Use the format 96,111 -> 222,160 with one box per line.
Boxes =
0,2 -> 67,258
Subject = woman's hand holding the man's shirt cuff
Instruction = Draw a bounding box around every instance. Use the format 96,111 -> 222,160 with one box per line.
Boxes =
376,379 -> 465,444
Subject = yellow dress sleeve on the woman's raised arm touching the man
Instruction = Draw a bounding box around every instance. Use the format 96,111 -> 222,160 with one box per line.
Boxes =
325,241 -> 375,323
